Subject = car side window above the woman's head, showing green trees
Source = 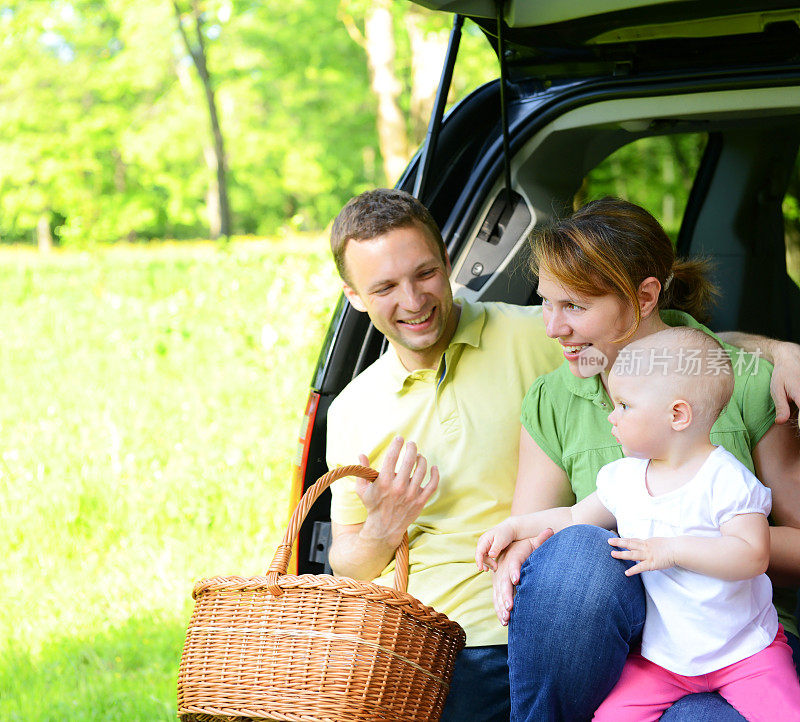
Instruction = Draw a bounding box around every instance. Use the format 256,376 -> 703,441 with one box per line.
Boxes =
575,133 -> 708,243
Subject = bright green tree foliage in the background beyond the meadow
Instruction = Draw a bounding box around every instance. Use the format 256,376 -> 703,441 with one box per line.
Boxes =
0,0 -> 493,246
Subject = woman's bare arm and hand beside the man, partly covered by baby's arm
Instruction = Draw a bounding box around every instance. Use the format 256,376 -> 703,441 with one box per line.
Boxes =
493,428 -> 575,624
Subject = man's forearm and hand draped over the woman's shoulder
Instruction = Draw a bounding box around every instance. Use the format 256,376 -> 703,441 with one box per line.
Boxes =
717,331 -> 800,424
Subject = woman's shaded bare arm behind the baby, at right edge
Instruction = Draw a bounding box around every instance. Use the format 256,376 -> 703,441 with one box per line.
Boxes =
753,424 -> 800,586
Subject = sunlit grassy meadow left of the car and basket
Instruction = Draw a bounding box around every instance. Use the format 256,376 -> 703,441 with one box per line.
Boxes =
0,237 -> 338,722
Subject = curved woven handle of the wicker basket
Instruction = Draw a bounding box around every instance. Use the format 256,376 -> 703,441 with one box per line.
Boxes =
267,465 -> 408,597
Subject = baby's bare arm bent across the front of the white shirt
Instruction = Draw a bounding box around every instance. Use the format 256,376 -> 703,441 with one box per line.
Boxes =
608,514 -> 769,581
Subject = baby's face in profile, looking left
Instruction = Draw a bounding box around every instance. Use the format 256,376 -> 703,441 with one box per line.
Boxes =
608,370 -> 672,459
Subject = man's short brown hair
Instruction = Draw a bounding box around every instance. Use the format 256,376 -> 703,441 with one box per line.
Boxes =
331,188 -> 447,283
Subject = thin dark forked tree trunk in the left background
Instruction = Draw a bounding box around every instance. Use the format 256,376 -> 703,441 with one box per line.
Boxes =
172,0 -> 231,238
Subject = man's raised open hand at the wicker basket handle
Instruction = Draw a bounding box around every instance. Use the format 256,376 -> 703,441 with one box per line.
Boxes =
355,436 -> 439,548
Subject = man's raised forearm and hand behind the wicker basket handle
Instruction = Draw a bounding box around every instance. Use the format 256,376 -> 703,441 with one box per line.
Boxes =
328,436 -> 439,580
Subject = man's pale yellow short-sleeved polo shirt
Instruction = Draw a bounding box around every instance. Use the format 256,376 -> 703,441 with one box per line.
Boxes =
327,300 -> 563,646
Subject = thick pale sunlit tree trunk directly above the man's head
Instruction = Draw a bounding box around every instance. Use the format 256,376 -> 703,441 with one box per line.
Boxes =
364,0 -> 409,184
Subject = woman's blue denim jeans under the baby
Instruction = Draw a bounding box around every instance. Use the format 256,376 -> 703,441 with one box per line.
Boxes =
510,526 -> 744,722
